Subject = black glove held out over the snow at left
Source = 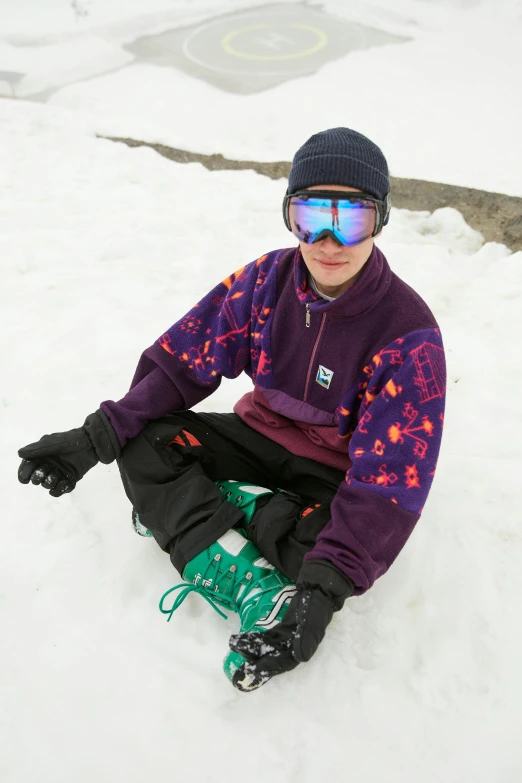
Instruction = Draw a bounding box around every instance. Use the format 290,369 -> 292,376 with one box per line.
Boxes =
18,410 -> 121,498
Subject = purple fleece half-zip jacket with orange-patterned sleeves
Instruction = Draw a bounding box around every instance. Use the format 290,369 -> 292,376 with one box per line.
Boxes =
101,246 -> 446,595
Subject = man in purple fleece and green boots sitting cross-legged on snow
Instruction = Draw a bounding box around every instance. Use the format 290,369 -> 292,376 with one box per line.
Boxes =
19,128 -> 445,691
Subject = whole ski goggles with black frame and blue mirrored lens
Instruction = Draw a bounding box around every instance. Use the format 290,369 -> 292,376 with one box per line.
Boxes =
283,190 -> 390,245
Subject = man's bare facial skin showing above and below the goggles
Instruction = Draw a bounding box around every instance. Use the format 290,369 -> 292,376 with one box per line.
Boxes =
299,185 -> 380,296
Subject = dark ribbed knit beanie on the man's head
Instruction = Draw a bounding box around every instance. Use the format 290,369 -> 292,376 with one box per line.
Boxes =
287,128 -> 390,199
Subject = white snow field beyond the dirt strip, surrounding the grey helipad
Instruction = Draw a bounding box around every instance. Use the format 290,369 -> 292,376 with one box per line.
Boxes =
0,0 -> 522,196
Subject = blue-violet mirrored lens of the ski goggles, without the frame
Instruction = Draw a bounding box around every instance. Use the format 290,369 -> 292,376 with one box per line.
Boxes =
288,196 -> 376,245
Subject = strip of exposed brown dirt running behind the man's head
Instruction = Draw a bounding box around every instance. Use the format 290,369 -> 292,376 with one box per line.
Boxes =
100,136 -> 522,251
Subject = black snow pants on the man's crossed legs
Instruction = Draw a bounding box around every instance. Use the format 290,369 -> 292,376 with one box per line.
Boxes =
119,411 -> 344,581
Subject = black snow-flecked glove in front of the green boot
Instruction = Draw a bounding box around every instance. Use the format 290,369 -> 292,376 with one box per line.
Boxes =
229,560 -> 354,691
